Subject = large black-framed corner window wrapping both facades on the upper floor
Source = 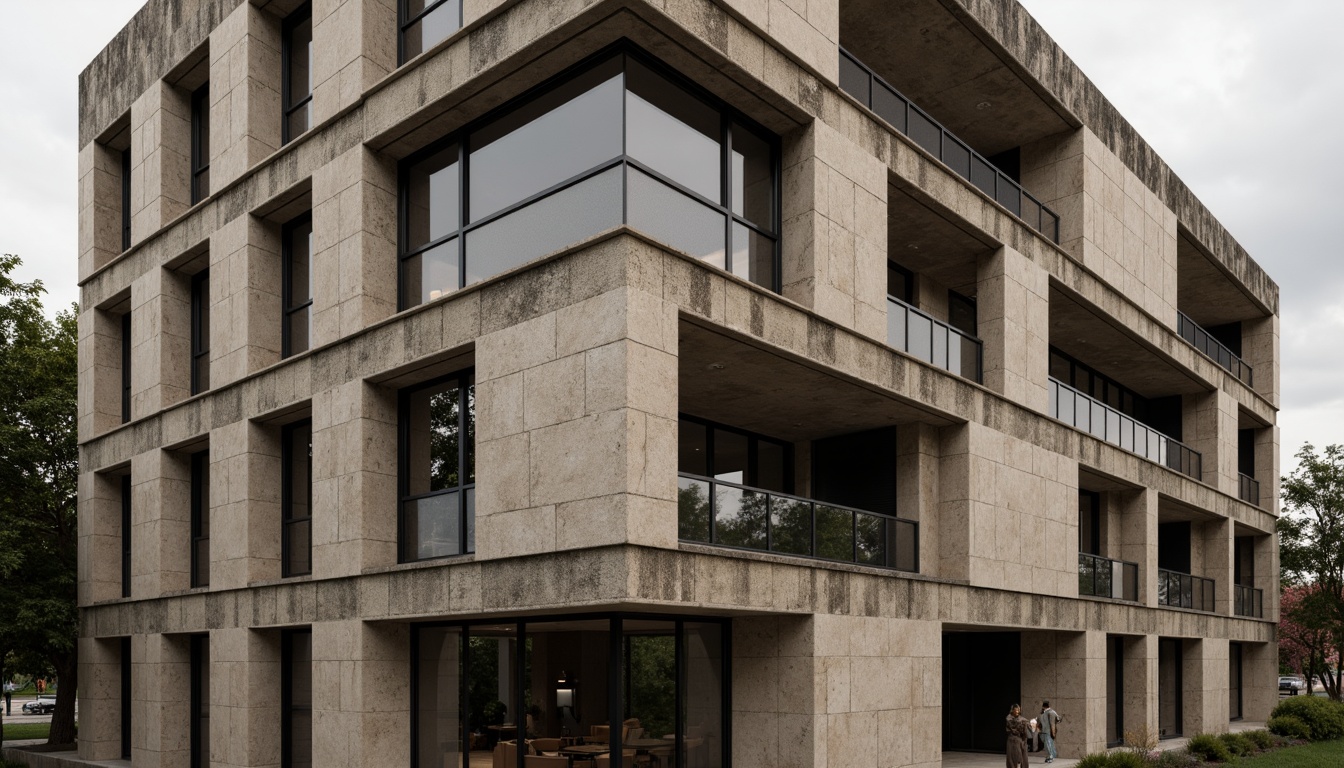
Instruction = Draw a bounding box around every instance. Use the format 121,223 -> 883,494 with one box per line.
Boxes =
401,45 -> 778,308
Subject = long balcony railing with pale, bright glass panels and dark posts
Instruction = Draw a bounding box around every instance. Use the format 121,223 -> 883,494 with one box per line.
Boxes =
1050,378 -> 1203,480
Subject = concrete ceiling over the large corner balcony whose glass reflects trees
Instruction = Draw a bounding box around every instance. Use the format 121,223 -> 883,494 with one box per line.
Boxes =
677,320 -> 949,441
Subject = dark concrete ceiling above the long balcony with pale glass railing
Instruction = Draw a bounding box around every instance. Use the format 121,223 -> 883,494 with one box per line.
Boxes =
1050,285 -> 1207,397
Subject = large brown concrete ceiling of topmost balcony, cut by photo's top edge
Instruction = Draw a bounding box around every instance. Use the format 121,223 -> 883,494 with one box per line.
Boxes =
840,0 -> 1071,155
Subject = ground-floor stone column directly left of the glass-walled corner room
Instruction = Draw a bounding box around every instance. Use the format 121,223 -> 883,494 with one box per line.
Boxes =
313,620 -> 411,768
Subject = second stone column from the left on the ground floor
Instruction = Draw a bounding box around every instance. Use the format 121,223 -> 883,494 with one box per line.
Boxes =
130,635 -> 191,768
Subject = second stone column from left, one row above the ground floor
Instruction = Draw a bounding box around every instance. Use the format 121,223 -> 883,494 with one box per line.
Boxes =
130,449 -> 191,600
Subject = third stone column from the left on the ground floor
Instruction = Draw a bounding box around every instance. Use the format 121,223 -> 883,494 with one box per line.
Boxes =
211,628 -> 280,768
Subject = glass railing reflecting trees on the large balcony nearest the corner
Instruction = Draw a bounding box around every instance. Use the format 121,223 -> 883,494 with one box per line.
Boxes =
677,472 -> 919,573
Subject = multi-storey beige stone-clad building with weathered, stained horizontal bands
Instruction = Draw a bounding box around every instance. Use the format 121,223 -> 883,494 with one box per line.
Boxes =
65,0 -> 1279,768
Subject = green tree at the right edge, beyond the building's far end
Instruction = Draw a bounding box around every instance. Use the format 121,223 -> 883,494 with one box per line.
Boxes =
1278,444 -> 1344,701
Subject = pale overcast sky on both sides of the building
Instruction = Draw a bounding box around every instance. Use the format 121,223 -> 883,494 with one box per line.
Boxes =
0,0 -> 1344,472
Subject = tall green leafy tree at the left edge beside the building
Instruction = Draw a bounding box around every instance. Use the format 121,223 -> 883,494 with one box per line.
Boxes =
0,254 -> 79,744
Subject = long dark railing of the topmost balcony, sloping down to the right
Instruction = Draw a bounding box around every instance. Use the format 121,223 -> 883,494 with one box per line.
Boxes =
840,48 -> 1059,243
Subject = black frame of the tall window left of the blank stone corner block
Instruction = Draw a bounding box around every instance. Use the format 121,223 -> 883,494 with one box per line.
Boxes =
396,367 -> 476,562
